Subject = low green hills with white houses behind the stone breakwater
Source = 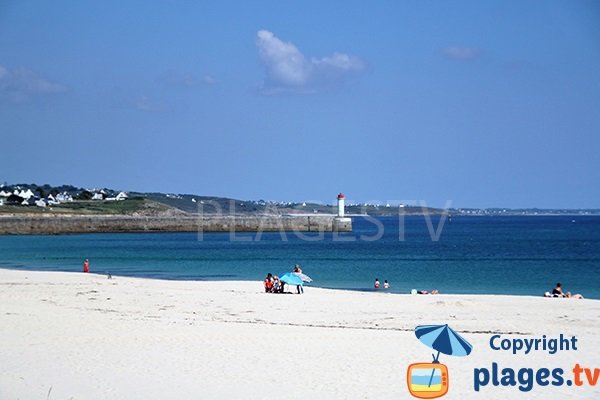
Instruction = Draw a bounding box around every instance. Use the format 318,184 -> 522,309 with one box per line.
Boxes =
0,183 -> 600,216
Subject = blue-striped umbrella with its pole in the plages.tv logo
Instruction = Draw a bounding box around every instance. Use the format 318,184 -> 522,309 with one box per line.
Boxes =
415,324 -> 473,386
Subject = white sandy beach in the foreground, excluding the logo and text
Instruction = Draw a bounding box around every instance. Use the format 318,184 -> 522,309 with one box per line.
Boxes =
0,269 -> 600,400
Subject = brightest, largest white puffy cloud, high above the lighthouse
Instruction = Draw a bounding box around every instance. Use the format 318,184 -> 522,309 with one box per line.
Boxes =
256,30 -> 365,94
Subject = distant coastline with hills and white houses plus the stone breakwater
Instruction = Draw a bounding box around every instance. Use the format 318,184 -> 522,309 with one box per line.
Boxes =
0,184 -> 600,235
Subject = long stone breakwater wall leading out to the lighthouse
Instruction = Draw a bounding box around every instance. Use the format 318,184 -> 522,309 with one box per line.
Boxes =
0,214 -> 352,235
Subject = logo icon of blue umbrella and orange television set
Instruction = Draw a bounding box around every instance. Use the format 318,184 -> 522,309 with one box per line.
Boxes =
406,324 -> 473,399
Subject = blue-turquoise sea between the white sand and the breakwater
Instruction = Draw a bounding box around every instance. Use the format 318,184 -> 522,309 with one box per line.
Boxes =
0,215 -> 600,299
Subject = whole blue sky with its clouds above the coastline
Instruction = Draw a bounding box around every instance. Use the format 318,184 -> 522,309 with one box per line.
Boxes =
0,0 -> 600,208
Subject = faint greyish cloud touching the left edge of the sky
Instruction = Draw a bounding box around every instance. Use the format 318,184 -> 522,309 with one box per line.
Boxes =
0,65 -> 66,103
